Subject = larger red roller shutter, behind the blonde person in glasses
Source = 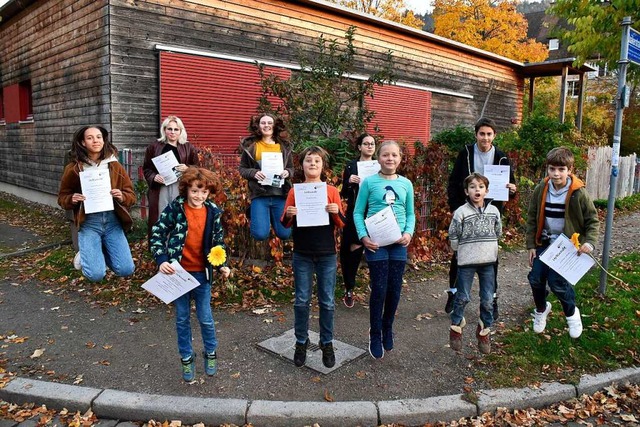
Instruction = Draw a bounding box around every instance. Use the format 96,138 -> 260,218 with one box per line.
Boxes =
160,51 -> 291,154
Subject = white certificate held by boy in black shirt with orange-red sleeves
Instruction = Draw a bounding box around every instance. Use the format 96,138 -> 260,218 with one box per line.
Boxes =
293,182 -> 329,227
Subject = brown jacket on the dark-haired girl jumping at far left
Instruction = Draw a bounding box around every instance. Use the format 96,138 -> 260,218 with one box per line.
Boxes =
58,161 -> 136,231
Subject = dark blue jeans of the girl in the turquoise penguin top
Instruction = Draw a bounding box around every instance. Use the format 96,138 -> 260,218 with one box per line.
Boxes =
364,243 -> 407,336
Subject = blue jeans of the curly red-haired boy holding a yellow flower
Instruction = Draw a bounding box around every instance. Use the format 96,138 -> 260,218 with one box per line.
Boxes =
173,271 -> 218,359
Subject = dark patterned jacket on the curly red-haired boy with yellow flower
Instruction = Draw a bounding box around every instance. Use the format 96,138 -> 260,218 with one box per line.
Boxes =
149,196 -> 229,283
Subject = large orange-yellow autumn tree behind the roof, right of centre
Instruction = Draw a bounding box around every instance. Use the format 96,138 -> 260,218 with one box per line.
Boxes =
433,0 -> 548,62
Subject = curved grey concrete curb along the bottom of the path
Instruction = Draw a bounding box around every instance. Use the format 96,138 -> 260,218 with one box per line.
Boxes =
0,368 -> 640,427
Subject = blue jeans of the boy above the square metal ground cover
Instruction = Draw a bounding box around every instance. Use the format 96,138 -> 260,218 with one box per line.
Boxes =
293,252 -> 338,345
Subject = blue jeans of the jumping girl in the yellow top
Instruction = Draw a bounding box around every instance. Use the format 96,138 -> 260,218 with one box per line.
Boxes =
249,196 -> 291,240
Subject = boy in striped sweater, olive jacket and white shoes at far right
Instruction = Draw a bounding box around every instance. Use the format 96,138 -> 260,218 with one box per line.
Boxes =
527,147 -> 600,338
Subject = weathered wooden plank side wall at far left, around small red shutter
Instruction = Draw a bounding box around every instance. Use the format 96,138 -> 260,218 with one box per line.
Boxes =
0,0 -> 110,194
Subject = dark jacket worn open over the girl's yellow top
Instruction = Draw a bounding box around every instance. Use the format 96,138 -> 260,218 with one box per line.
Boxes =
238,136 -> 293,200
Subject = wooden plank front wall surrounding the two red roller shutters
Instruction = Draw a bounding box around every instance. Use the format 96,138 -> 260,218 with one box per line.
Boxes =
109,0 -> 523,158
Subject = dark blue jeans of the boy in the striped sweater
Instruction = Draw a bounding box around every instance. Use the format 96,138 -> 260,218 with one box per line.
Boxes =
528,247 -> 576,317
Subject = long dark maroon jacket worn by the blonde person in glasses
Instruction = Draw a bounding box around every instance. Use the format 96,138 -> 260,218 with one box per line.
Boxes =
142,141 -> 200,236
